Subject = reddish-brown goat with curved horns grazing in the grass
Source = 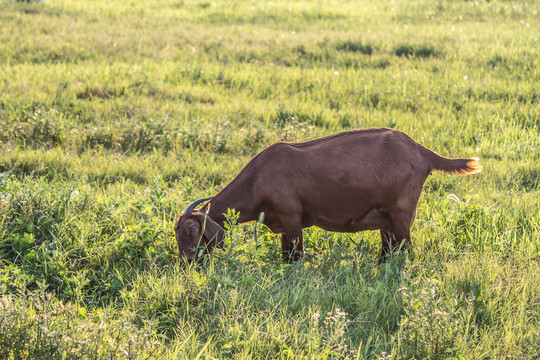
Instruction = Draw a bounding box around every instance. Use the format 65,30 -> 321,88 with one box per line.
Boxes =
175,128 -> 481,261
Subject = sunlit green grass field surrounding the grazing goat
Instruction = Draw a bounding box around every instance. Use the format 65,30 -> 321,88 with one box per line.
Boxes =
0,0 -> 540,359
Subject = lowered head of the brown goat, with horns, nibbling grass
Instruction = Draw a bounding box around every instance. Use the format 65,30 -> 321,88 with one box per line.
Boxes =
174,197 -> 224,261
